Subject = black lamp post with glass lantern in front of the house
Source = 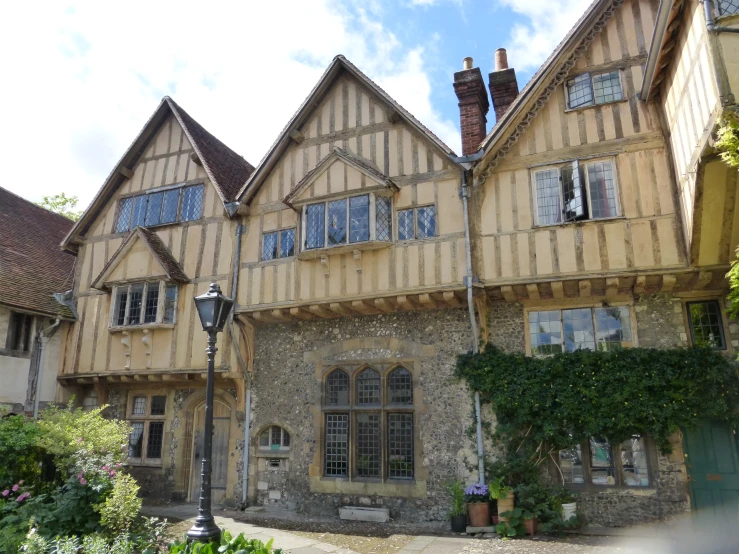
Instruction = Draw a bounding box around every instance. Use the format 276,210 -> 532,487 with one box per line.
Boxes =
187,283 -> 234,542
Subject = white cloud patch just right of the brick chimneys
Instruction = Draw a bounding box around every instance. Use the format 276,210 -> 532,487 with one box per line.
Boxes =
497,0 -> 592,71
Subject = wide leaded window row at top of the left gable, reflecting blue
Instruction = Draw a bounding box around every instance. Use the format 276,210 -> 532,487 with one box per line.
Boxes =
115,184 -> 205,233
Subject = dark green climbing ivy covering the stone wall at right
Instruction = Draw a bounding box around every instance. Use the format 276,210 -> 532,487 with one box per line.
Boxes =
456,345 -> 739,454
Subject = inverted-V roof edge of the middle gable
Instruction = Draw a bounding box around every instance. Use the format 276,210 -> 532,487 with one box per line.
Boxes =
237,55 -> 454,203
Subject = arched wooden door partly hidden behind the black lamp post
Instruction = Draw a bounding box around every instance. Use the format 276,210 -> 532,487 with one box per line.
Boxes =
190,400 -> 231,505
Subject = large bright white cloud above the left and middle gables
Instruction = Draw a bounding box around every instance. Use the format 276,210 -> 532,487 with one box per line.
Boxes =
0,0 -> 460,205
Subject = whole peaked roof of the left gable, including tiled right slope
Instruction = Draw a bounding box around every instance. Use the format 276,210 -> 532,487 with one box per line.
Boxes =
62,96 -> 254,249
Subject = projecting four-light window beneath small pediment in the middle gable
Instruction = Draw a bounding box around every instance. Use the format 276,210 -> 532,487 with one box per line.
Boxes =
303,193 -> 392,250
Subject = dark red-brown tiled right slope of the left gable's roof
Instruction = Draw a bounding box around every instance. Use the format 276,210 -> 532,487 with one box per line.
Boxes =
164,96 -> 254,202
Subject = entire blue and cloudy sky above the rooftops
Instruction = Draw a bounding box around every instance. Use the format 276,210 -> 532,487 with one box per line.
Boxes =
0,0 -> 590,208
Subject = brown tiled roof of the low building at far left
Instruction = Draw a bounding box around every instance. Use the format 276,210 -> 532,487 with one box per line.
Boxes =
0,187 -> 75,318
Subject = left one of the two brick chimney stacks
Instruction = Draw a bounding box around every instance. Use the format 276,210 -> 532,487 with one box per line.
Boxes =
454,58 -> 490,156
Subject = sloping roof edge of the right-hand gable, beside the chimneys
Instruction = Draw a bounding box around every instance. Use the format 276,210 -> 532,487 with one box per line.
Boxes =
476,0 -> 624,175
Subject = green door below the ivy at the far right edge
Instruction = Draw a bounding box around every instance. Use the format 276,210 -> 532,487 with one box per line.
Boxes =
685,421 -> 739,529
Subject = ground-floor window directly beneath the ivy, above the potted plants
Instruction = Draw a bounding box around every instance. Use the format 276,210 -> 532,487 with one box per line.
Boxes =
552,435 -> 652,488
